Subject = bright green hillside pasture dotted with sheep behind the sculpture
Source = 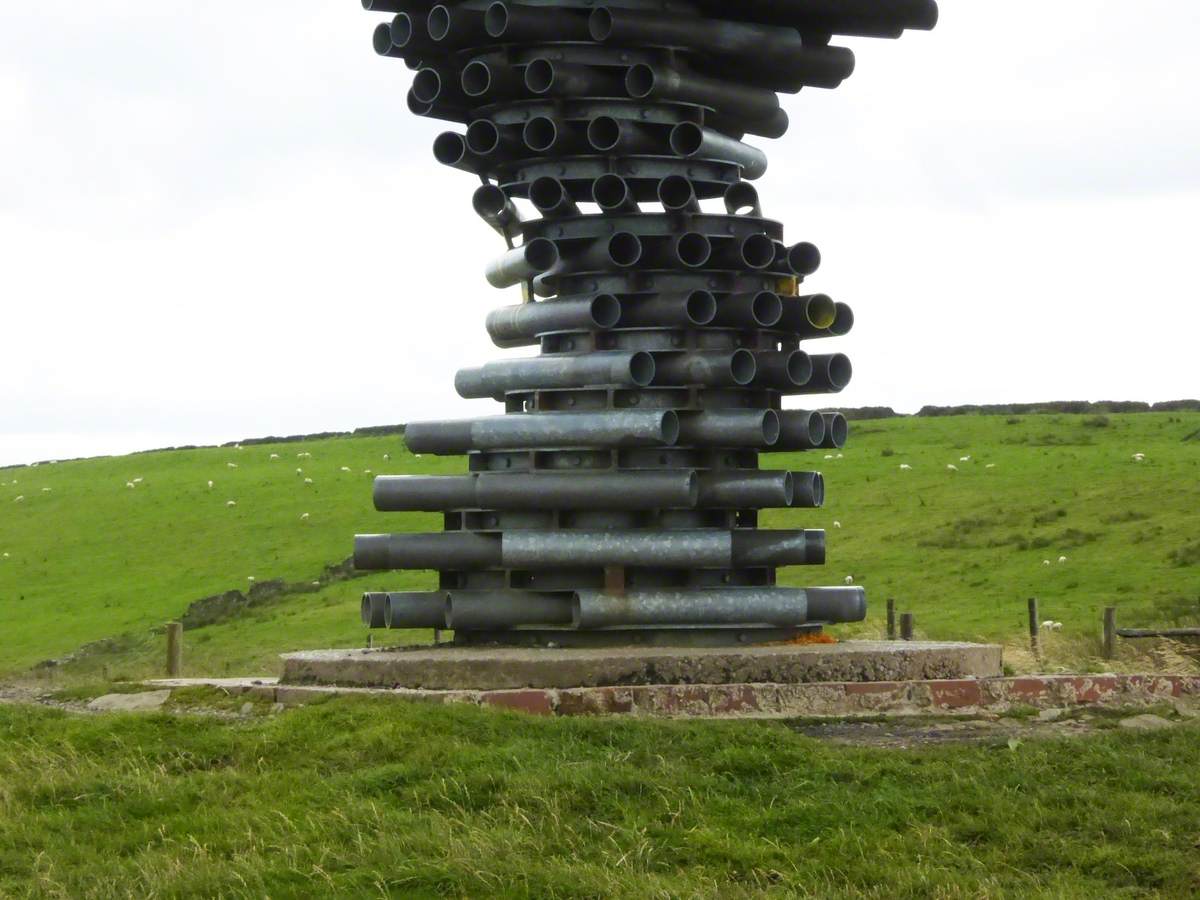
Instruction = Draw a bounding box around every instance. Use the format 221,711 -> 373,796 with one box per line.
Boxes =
0,413 -> 1200,673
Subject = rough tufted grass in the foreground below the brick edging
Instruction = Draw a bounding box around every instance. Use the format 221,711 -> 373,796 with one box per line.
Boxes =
0,700 -> 1200,900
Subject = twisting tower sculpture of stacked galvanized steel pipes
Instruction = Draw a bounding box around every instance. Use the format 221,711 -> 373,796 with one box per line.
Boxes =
355,0 -> 937,646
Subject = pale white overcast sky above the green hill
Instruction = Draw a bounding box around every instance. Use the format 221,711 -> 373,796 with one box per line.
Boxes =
0,0 -> 1200,464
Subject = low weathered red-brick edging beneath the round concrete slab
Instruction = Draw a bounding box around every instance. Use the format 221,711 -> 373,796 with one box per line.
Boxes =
148,674 -> 1200,718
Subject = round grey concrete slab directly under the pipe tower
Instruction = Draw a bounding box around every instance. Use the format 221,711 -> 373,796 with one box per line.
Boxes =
281,641 -> 1001,690
